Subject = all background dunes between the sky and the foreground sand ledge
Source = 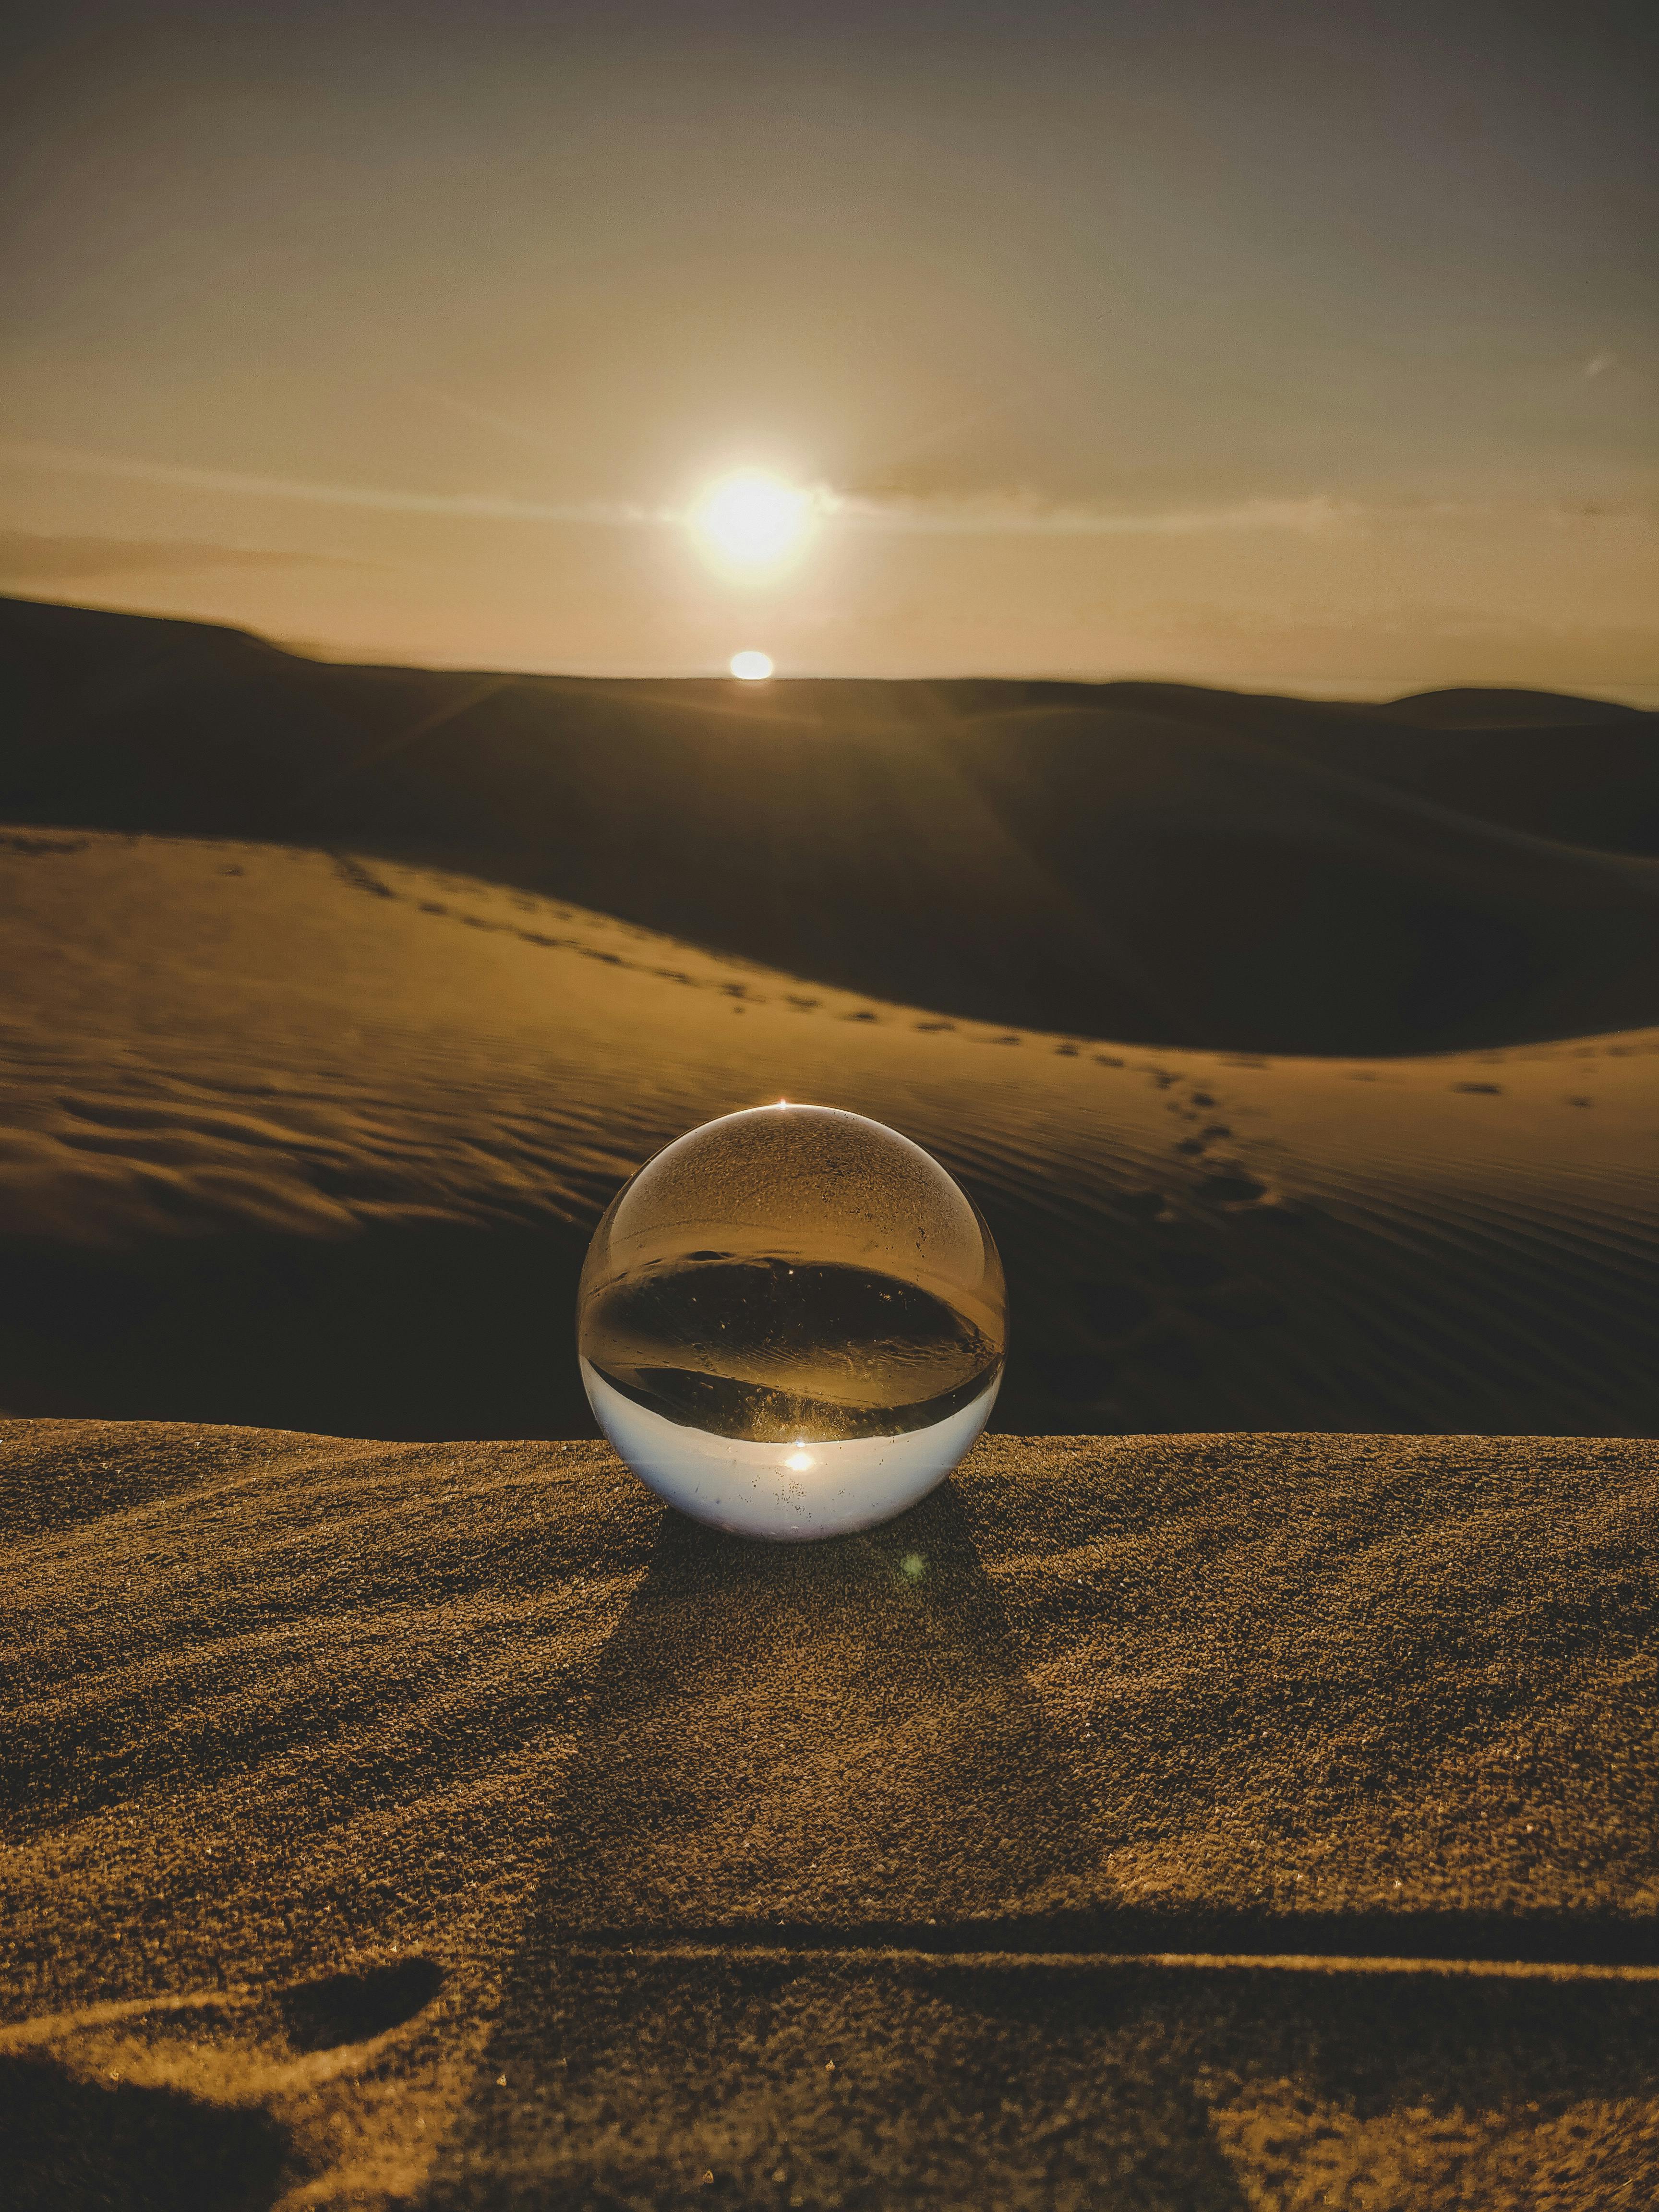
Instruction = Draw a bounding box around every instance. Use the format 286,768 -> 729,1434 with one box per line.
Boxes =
0,601 -> 1659,1436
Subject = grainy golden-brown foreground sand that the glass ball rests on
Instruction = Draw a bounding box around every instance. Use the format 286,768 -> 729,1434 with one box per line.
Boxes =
0,1420 -> 1659,2212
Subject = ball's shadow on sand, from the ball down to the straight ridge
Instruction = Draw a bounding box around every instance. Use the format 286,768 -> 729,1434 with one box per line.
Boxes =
493,1487 -> 1097,1947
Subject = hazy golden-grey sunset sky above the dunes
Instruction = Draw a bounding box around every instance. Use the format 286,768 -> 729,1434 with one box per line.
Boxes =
0,0 -> 1659,701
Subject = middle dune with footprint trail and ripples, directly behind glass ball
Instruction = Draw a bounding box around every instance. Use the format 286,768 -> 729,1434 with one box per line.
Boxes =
0,830 -> 1659,1436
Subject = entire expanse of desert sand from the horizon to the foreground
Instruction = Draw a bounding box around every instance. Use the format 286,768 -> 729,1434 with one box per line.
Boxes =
0,606 -> 1659,2212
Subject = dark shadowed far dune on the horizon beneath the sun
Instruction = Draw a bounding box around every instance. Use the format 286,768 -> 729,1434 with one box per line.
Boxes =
13,601 -> 1659,1053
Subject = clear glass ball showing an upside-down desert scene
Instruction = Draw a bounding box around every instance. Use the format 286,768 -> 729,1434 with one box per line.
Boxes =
577,1104 -> 1007,1539
